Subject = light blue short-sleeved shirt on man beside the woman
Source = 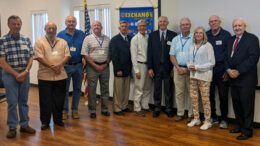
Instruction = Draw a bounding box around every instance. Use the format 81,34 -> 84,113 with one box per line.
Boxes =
170,33 -> 193,66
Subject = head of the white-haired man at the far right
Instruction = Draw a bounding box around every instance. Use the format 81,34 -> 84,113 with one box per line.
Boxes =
232,18 -> 246,37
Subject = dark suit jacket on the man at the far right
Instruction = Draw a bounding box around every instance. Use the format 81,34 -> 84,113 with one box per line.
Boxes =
225,32 -> 259,87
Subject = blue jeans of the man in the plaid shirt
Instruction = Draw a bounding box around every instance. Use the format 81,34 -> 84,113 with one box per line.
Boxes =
2,70 -> 30,129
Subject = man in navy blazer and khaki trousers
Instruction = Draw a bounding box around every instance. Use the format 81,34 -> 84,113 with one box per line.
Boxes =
109,21 -> 132,116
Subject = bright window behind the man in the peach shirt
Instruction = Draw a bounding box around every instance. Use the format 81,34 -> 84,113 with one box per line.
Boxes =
32,11 -> 48,46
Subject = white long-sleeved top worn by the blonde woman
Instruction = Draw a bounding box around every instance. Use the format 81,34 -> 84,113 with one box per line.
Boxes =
187,42 -> 215,82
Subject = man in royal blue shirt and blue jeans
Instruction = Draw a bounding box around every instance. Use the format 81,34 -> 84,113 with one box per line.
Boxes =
57,16 -> 85,120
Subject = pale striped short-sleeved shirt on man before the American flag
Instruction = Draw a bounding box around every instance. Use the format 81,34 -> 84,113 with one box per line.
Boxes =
81,34 -> 110,63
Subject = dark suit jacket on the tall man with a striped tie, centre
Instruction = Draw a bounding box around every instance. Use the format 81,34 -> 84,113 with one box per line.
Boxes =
147,30 -> 177,74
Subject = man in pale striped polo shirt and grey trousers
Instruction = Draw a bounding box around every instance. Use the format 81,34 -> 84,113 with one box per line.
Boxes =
81,21 -> 110,118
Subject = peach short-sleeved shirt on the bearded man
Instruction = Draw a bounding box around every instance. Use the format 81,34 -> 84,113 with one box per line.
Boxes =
34,37 -> 70,81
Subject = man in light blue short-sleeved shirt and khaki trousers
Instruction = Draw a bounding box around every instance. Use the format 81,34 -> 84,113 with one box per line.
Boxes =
170,18 -> 192,122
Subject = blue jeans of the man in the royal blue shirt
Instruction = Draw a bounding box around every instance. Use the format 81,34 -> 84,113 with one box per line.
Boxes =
63,63 -> 83,112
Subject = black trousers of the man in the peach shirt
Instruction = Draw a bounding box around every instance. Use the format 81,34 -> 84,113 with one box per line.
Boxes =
38,79 -> 66,125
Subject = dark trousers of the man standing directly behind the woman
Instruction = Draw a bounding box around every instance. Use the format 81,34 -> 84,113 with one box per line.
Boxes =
210,74 -> 229,121
